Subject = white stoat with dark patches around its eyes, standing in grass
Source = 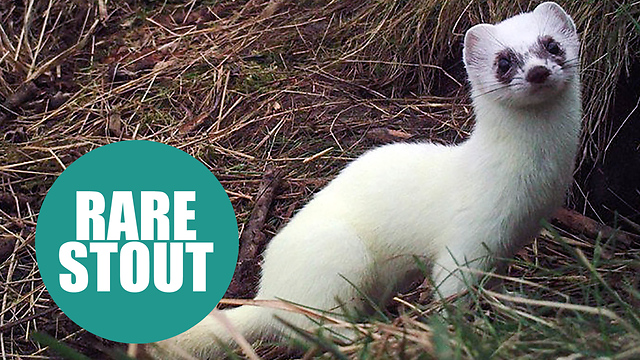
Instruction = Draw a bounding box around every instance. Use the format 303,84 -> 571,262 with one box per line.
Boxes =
149,2 -> 581,358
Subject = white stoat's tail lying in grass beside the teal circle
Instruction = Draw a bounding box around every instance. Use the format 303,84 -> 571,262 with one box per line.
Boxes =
146,305 -> 273,359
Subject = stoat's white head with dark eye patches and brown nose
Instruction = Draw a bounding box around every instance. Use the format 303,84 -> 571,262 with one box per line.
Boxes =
464,2 -> 580,106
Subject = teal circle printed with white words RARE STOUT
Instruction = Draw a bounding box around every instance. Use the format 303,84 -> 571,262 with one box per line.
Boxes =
36,140 -> 238,343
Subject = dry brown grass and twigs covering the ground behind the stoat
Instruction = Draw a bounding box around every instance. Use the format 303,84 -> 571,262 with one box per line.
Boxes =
0,0 -> 640,358
